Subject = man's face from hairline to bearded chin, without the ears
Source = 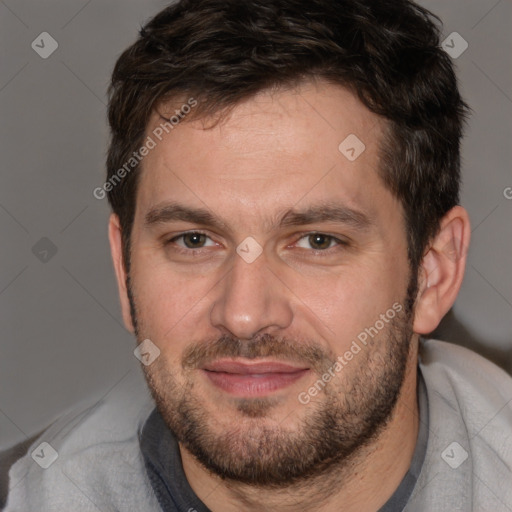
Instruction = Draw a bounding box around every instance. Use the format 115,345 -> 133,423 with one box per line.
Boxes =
124,82 -> 412,485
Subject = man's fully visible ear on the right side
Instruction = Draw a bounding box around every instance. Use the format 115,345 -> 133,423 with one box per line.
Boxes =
413,206 -> 471,334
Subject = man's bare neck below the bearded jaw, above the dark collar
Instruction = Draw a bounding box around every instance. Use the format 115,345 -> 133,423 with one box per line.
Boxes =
180,340 -> 419,512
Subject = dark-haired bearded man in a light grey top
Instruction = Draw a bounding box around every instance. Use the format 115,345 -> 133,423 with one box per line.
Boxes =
1,0 -> 512,512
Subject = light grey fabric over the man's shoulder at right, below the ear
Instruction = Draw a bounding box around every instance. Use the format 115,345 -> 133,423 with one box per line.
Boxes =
406,339 -> 512,512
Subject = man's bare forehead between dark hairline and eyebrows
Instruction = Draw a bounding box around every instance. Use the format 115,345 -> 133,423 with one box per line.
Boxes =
137,83 -> 396,232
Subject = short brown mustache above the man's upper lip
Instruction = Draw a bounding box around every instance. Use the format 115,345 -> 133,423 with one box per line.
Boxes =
182,334 -> 336,373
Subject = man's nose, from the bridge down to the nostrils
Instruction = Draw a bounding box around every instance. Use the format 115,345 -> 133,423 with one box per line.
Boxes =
210,249 -> 293,340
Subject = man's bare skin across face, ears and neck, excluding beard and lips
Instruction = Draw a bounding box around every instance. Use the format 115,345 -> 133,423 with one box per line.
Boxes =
109,82 -> 470,512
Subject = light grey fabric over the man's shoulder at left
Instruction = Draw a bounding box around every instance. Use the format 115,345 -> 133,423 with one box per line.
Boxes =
5,368 -> 162,512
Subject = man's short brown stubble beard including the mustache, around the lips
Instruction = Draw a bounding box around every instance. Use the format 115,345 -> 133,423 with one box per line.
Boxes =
129,276 -> 413,489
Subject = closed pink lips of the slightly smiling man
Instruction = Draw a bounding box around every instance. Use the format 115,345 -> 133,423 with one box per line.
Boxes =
201,359 -> 310,398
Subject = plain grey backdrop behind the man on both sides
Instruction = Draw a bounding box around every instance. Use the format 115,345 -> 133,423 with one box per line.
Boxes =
0,0 -> 512,449
